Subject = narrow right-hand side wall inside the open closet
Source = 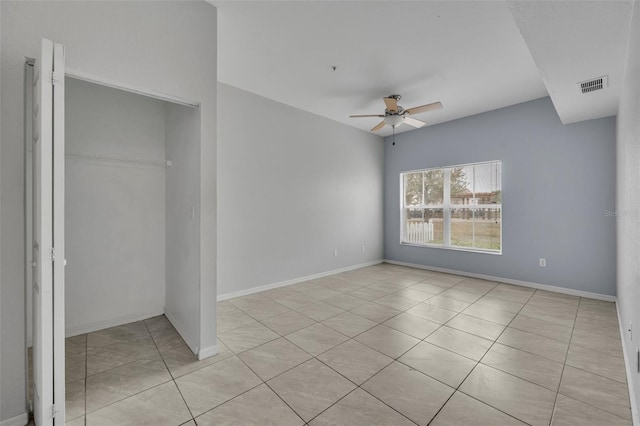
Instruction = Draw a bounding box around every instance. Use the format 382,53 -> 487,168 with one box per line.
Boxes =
165,104 -> 200,353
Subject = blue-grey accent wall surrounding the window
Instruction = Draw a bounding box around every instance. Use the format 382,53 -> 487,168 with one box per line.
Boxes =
384,98 -> 616,295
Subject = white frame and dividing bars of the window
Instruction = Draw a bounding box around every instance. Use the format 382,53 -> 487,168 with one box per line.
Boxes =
400,160 -> 503,255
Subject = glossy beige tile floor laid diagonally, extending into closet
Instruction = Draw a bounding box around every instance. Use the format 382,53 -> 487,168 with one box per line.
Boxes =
46,264 -> 631,426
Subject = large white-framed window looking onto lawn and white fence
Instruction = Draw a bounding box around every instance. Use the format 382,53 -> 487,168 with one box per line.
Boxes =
400,161 -> 502,254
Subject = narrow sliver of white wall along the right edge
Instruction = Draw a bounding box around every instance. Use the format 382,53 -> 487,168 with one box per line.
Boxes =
616,1 -> 640,424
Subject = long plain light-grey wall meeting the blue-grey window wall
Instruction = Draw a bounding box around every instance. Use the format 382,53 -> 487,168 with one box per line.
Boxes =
218,83 -> 383,296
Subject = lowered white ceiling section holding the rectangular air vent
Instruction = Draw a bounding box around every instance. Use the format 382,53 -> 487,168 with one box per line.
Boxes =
512,1 -> 631,124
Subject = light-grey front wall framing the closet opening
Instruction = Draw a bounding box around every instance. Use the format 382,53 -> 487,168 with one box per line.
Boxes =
0,1 -> 217,421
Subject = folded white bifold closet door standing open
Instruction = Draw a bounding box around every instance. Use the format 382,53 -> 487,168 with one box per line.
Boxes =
33,40 -> 65,426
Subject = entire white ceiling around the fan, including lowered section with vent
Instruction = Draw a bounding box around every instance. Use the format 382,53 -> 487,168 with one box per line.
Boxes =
211,0 -> 630,136
